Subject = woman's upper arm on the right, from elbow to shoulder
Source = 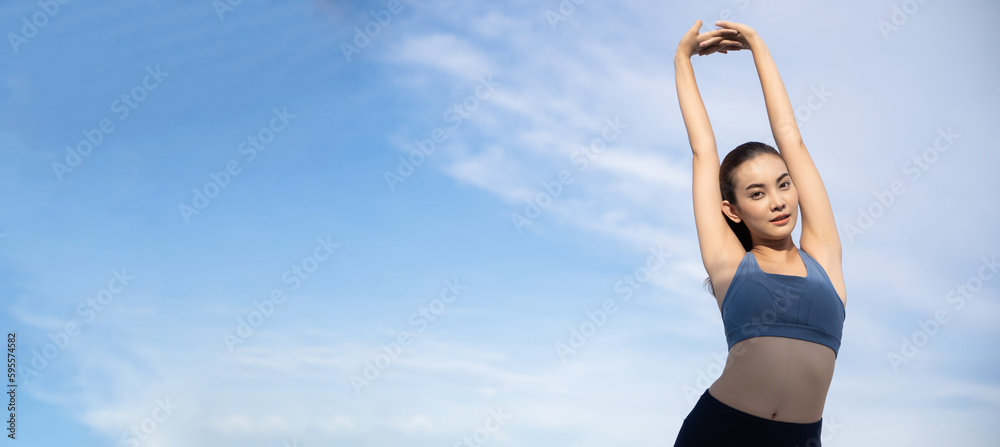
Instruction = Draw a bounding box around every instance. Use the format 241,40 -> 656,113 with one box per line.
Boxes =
779,139 -> 843,264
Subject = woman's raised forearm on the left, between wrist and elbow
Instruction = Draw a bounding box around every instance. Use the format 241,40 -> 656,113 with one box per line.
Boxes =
674,54 -> 719,158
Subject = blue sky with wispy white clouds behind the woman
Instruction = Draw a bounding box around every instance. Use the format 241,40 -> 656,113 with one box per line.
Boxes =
0,0 -> 1000,447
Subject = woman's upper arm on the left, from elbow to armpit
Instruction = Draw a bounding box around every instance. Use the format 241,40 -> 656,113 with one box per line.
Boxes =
692,152 -> 746,276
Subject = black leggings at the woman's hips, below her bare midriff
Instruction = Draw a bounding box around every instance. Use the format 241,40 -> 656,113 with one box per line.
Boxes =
674,389 -> 823,447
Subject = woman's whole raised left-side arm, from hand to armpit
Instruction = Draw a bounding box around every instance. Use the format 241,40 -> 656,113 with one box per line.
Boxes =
674,20 -> 746,277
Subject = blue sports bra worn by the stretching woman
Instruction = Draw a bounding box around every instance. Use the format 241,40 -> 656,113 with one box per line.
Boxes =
722,247 -> 846,356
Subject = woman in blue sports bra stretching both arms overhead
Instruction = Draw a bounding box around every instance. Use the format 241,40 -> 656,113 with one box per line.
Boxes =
674,20 -> 846,447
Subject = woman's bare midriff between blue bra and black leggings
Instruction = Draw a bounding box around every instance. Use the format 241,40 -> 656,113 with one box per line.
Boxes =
709,336 -> 836,424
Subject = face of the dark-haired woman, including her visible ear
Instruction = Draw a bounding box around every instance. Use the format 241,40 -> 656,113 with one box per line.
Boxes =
722,154 -> 799,243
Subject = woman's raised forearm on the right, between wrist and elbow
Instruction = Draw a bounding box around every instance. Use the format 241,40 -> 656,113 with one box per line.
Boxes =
747,35 -> 802,150
